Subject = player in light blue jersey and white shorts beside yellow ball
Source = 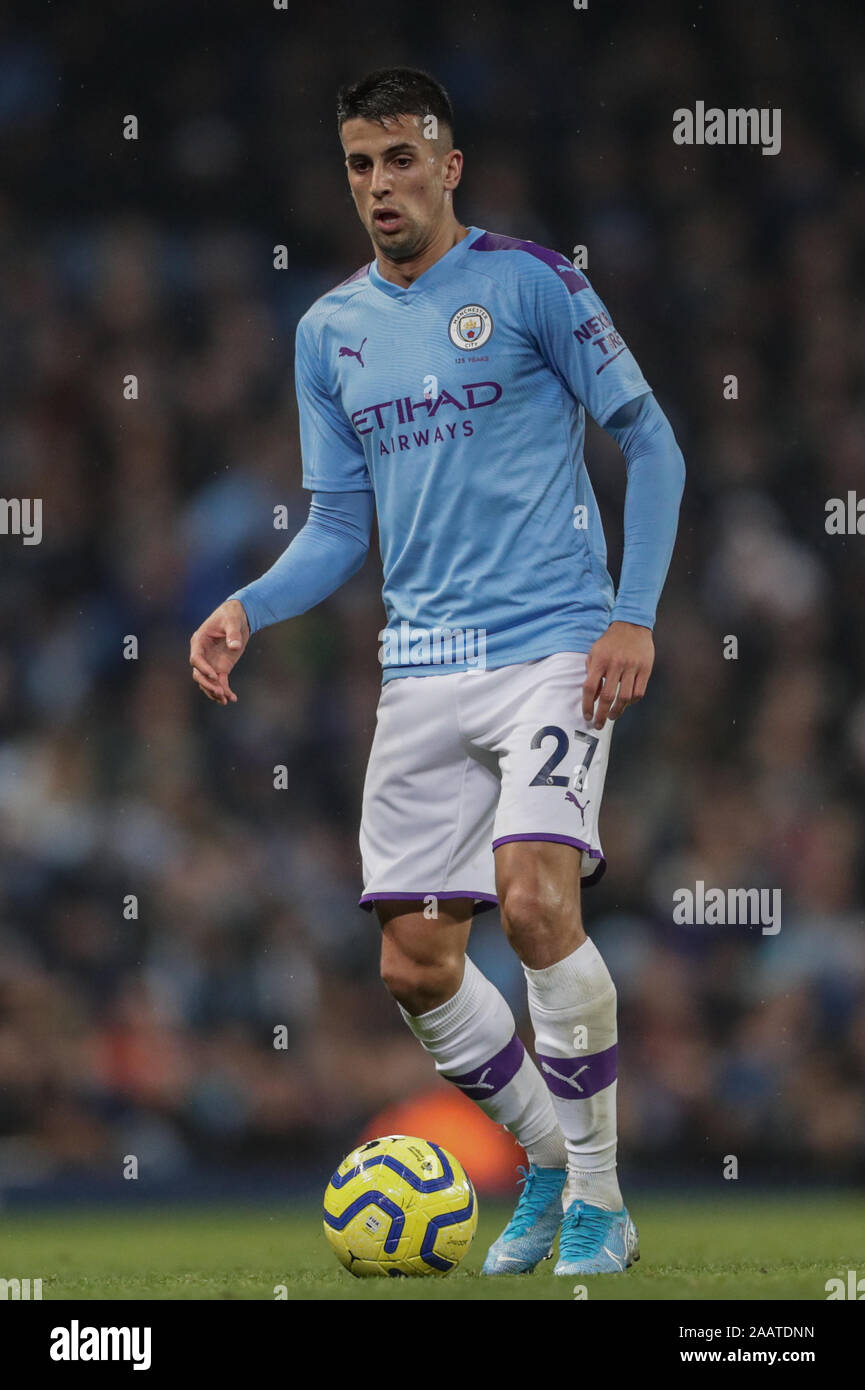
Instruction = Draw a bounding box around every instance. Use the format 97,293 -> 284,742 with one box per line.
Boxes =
191,68 -> 684,1276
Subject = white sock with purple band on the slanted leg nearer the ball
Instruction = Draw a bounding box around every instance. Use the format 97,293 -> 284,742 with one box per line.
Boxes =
399,956 -> 565,1168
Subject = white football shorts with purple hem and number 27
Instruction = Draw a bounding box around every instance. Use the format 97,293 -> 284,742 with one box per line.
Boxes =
360,652 -> 613,910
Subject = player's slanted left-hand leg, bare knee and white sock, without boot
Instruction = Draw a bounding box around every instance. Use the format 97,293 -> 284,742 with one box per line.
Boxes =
375,898 -> 565,1169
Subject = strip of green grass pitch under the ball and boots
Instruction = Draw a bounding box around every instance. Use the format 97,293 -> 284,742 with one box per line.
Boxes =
0,1188 -> 865,1302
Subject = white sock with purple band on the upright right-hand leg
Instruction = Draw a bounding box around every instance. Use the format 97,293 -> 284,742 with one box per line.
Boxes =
523,938 -> 623,1211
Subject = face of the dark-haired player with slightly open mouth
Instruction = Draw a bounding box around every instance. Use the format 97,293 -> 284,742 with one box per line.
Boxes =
339,115 -> 462,261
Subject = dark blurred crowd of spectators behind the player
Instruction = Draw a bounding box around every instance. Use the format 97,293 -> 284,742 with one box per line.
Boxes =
0,0 -> 865,1200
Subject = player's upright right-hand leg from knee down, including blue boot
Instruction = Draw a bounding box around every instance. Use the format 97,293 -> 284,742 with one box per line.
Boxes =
495,841 -> 637,1273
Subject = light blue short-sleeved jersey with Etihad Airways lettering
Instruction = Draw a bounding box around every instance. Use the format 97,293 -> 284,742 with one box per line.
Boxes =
296,227 -> 653,680
